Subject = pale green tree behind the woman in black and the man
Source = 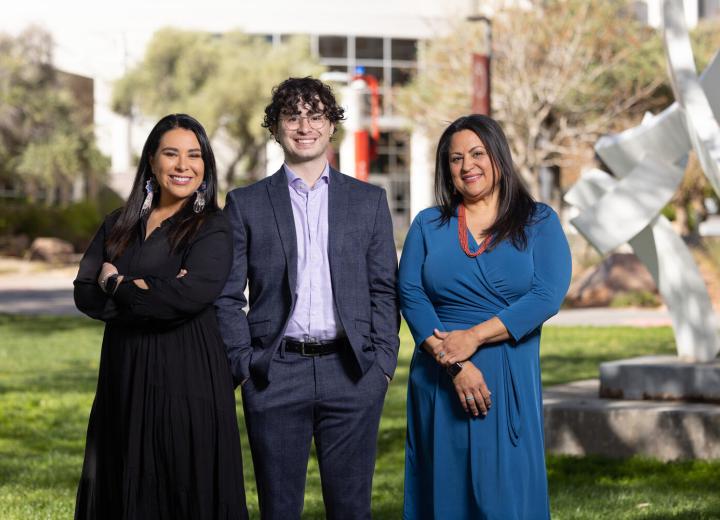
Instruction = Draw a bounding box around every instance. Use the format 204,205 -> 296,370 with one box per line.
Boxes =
113,29 -> 324,185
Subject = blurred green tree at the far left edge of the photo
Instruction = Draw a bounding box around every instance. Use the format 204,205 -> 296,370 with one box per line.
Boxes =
0,27 -> 109,204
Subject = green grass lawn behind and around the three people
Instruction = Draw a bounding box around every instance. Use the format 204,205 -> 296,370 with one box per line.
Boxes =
0,316 -> 720,520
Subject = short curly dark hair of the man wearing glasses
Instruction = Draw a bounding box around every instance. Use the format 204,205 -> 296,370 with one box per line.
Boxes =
263,76 -> 345,135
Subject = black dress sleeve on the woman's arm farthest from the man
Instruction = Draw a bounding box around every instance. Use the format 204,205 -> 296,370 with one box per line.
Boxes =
73,212 -> 119,321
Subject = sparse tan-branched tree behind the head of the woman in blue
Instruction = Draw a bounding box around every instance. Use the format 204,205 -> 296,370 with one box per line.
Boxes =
400,0 -> 671,204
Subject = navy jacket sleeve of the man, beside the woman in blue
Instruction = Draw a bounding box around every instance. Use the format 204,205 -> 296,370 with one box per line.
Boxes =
366,187 -> 400,377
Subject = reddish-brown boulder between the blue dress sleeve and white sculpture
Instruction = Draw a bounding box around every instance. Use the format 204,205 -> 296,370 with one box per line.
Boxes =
565,253 -> 657,307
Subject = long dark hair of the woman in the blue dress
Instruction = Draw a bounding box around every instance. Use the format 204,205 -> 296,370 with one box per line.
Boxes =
435,114 -> 535,249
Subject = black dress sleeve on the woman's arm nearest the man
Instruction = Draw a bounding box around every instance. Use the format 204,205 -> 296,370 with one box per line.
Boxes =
113,216 -> 232,325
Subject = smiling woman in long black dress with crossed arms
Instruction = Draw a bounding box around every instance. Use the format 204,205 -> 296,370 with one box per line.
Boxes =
75,114 -> 247,520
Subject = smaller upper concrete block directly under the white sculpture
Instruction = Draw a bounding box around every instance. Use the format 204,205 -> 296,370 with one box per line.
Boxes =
599,356 -> 720,404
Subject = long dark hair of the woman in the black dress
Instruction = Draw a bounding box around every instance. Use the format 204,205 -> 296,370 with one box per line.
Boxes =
105,114 -> 219,260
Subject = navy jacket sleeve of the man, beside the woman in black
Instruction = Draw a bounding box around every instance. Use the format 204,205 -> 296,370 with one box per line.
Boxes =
215,193 -> 252,384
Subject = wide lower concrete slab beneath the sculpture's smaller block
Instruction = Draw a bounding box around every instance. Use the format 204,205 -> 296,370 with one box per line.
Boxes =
544,379 -> 720,461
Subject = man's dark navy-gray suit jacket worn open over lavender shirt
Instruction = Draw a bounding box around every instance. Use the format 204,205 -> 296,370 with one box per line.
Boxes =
215,168 -> 399,385
